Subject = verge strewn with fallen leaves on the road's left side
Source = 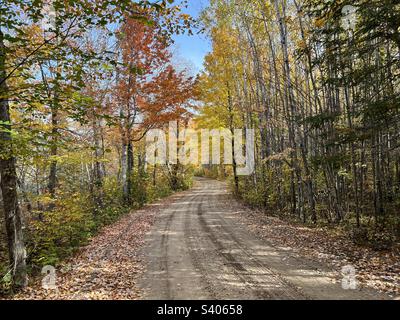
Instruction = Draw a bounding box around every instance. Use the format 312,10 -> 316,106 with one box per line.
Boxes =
10,198 -> 178,300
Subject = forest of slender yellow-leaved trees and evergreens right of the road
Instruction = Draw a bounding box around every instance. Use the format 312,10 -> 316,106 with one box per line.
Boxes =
197,0 -> 400,242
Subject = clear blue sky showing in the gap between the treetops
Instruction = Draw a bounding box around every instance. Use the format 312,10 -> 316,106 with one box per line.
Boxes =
173,0 -> 211,73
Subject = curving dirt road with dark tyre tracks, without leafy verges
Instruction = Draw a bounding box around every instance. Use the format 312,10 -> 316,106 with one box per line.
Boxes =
140,179 -> 390,300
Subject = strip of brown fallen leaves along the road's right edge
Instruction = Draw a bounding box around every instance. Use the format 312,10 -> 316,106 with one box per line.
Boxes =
234,200 -> 400,298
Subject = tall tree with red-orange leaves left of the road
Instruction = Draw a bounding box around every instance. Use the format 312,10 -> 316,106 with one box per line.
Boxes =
114,19 -> 192,203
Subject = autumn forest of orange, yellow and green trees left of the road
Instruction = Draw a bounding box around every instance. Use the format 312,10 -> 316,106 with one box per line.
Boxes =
0,1 -> 198,292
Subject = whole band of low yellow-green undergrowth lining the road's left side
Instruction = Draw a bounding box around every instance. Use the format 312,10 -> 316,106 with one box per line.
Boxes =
23,171 -> 177,270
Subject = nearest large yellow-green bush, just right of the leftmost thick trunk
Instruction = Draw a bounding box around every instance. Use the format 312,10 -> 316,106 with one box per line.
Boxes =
28,181 -> 115,267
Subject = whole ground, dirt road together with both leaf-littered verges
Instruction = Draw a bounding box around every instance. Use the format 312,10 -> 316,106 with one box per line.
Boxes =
8,179 -> 400,300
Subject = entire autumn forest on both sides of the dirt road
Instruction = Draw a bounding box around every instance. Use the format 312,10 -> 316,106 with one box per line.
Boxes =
0,0 -> 400,295
